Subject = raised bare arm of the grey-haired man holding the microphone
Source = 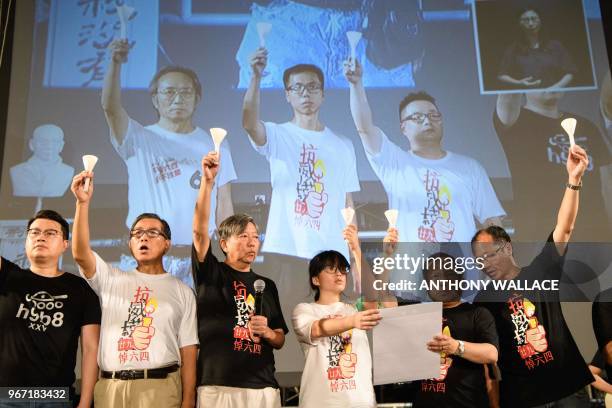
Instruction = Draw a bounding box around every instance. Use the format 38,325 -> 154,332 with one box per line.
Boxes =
193,152 -> 219,262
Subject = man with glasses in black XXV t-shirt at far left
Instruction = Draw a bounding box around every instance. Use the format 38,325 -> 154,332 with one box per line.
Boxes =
0,210 -> 101,407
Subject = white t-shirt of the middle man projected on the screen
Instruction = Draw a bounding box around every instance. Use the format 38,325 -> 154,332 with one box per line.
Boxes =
251,122 -> 359,259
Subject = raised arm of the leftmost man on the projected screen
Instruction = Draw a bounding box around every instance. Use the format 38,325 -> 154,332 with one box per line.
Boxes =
102,39 -> 130,143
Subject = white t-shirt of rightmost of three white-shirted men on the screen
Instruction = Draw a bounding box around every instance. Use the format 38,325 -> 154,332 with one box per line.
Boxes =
366,135 -> 505,242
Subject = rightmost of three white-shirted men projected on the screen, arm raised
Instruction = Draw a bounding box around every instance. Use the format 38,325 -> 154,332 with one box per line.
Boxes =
345,61 -> 505,242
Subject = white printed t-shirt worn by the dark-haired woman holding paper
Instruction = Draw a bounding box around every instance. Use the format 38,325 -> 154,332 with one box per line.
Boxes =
292,302 -> 376,408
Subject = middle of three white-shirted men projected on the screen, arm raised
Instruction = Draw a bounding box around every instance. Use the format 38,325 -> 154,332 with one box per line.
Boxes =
242,48 -> 359,265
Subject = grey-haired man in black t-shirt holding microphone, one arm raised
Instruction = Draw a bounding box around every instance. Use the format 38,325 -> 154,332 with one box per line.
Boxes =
192,152 -> 288,408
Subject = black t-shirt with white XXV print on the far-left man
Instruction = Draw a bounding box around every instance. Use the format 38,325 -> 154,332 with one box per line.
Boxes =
0,258 -> 101,387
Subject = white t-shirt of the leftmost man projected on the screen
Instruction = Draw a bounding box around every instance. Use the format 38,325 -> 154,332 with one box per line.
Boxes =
111,119 -> 236,245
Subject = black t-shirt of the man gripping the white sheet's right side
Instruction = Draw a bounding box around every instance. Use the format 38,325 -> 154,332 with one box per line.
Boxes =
414,303 -> 498,408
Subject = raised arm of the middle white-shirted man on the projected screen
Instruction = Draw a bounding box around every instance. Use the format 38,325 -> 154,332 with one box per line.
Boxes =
242,48 -> 268,146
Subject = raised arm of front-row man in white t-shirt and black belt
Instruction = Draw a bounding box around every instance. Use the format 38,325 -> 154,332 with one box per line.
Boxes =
70,171 -> 96,279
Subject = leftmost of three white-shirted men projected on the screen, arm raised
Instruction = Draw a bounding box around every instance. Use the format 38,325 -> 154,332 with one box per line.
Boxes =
102,39 -> 236,246
